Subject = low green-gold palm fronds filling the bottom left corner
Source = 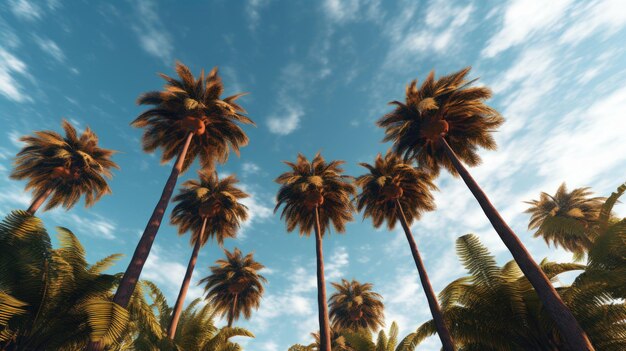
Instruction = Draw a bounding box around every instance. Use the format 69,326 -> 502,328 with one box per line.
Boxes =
0,211 -> 153,351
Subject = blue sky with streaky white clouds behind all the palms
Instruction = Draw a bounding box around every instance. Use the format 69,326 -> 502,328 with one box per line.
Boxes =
0,0 -> 626,351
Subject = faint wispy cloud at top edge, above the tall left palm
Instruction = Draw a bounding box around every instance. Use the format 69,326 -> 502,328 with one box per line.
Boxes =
133,0 -> 174,64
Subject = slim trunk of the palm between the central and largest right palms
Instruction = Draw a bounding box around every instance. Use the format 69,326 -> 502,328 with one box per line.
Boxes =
396,199 -> 455,351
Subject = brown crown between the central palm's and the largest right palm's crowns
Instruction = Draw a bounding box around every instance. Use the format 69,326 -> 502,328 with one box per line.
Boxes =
356,151 -> 437,229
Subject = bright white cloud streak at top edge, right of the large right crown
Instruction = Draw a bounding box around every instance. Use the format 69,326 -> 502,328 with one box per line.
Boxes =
482,0 -> 572,57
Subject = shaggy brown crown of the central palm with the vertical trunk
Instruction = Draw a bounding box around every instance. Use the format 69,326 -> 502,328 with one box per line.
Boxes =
274,153 -> 356,236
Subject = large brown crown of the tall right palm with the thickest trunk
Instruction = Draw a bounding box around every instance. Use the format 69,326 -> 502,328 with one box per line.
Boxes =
377,67 -> 504,176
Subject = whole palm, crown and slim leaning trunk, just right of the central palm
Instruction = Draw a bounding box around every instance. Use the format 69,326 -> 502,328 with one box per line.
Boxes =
356,152 -> 454,350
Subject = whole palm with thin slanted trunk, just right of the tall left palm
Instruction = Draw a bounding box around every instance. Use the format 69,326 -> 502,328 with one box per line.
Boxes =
168,171 -> 248,339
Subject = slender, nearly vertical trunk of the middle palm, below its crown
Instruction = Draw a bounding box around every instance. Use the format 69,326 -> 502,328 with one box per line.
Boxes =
315,207 -> 331,351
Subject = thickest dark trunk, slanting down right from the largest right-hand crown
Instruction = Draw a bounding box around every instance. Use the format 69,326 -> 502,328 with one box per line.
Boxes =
441,138 -> 594,351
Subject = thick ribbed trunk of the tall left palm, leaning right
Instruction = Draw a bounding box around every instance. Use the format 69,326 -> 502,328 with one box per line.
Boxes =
86,132 -> 193,351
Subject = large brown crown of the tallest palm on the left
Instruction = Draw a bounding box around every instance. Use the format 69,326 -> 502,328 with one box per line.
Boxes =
131,62 -> 254,175
